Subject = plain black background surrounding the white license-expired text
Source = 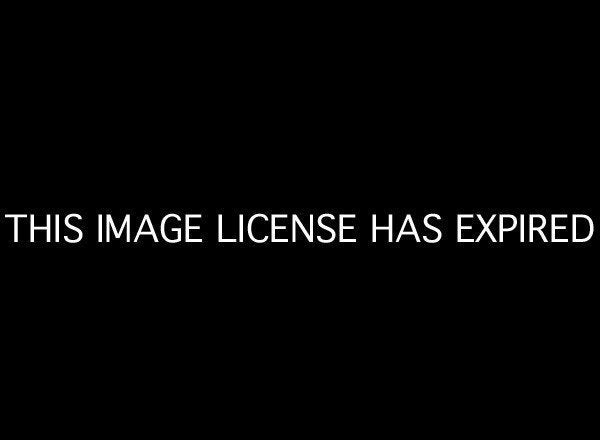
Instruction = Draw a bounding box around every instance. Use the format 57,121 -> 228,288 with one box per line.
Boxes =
1,5 -> 598,433
